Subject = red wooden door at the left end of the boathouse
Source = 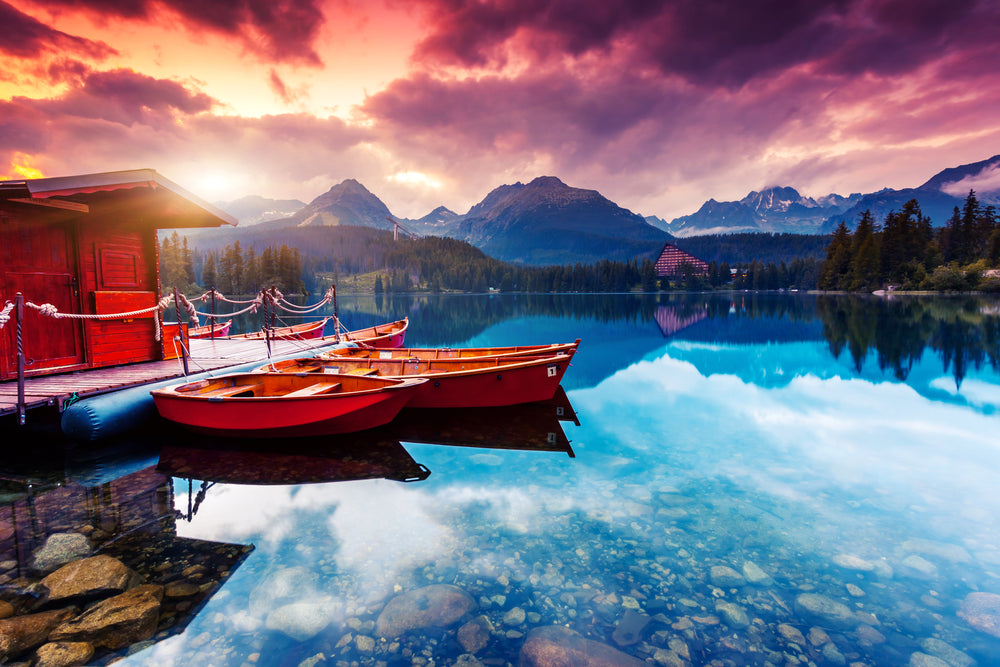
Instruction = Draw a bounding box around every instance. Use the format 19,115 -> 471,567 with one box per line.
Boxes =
0,217 -> 84,379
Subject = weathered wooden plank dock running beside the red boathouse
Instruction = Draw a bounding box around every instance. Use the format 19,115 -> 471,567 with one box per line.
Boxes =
0,336 -> 350,418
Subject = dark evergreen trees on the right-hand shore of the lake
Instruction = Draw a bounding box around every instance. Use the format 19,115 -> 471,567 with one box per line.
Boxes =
818,190 -> 1000,291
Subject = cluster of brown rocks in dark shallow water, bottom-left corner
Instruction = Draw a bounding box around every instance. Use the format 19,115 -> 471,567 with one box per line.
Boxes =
0,533 -> 251,667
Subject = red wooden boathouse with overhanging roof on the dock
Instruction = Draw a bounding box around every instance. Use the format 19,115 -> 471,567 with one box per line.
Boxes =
0,169 -> 236,381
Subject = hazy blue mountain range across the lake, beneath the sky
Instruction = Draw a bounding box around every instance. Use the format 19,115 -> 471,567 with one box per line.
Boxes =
218,155 -> 1000,265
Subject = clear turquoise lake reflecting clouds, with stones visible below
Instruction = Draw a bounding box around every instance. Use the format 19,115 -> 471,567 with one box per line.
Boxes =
0,293 -> 1000,667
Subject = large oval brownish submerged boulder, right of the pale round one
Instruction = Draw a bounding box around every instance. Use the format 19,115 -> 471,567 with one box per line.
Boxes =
375,584 -> 476,637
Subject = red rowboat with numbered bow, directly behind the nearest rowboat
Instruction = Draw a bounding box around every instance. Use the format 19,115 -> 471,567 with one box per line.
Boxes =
255,354 -> 572,408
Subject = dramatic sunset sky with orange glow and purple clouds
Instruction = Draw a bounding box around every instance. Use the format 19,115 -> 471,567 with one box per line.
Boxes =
0,0 -> 1000,220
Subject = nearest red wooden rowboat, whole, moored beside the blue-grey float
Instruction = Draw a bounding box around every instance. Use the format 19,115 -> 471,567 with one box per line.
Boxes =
150,373 -> 426,438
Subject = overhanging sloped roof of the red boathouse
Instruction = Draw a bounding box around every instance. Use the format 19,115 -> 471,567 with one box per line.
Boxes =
0,169 -> 237,229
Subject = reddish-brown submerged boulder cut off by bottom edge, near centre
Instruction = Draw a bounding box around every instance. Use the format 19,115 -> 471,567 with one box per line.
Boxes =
520,625 -> 646,667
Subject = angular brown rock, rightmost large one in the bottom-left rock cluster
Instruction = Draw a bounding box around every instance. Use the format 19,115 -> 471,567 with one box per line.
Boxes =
49,585 -> 163,650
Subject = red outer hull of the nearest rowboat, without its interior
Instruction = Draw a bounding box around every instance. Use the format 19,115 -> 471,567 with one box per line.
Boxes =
151,378 -> 424,438
